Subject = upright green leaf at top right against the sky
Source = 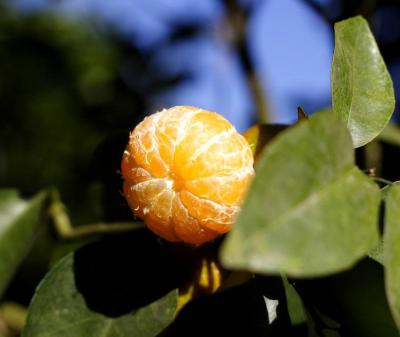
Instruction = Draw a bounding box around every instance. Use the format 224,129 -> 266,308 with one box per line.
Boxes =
332,16 -> 395,147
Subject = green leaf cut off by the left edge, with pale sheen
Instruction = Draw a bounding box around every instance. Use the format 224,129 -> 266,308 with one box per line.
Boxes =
0,189 -> 46,296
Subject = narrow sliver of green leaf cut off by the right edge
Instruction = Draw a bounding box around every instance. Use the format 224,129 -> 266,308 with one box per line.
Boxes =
384,182 -> 400,329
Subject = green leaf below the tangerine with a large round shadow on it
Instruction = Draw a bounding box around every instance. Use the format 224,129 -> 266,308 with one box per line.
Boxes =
22,231 -> 177,337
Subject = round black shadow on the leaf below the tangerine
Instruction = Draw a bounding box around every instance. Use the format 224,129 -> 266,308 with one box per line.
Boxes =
74,230 -> 177,317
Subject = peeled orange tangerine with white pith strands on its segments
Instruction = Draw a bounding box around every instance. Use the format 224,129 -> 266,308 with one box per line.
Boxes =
122,106 -> 254,244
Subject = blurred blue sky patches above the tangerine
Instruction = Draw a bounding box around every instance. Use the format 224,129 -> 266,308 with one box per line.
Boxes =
8,0 -> 333,131
